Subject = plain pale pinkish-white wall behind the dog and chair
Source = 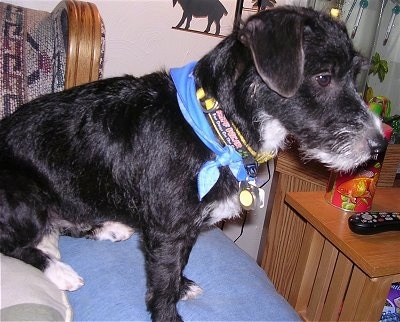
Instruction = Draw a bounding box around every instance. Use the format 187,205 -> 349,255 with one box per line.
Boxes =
5,0 -> 241,77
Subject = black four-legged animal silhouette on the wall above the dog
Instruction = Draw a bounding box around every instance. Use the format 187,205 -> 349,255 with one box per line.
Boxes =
172,0 -> 228,35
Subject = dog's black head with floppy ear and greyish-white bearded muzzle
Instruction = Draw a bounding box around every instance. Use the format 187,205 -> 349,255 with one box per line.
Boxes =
238,7 -> 386,170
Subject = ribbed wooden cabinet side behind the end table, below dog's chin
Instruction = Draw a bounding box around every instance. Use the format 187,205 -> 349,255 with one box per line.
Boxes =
259,151 -> 329,298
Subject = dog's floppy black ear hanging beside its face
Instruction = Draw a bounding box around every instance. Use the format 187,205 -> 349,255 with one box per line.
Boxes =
239,9 -> 304,97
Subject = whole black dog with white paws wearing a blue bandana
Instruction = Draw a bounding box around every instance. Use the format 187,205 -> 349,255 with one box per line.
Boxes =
0,7 -> 385,321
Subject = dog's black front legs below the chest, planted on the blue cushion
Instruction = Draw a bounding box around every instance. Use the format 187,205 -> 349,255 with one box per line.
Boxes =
143,231 -> 201,321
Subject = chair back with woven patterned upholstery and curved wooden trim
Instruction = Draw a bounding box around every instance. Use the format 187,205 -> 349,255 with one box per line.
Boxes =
0,0 -> 104,118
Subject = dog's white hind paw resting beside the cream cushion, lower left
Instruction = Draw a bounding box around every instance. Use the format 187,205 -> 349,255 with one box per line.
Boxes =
44,259 -> 85,291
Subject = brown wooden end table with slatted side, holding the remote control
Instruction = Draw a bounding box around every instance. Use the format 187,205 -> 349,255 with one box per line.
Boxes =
285,188 -> 400,321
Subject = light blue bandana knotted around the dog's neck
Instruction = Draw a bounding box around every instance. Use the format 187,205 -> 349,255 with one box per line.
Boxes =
170,62 -> 248,200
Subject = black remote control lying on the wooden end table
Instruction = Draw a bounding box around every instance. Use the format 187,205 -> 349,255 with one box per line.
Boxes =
349,211 -> 400,235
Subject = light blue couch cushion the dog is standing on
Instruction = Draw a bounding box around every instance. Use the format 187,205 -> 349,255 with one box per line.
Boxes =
59,228 -> 300,321
